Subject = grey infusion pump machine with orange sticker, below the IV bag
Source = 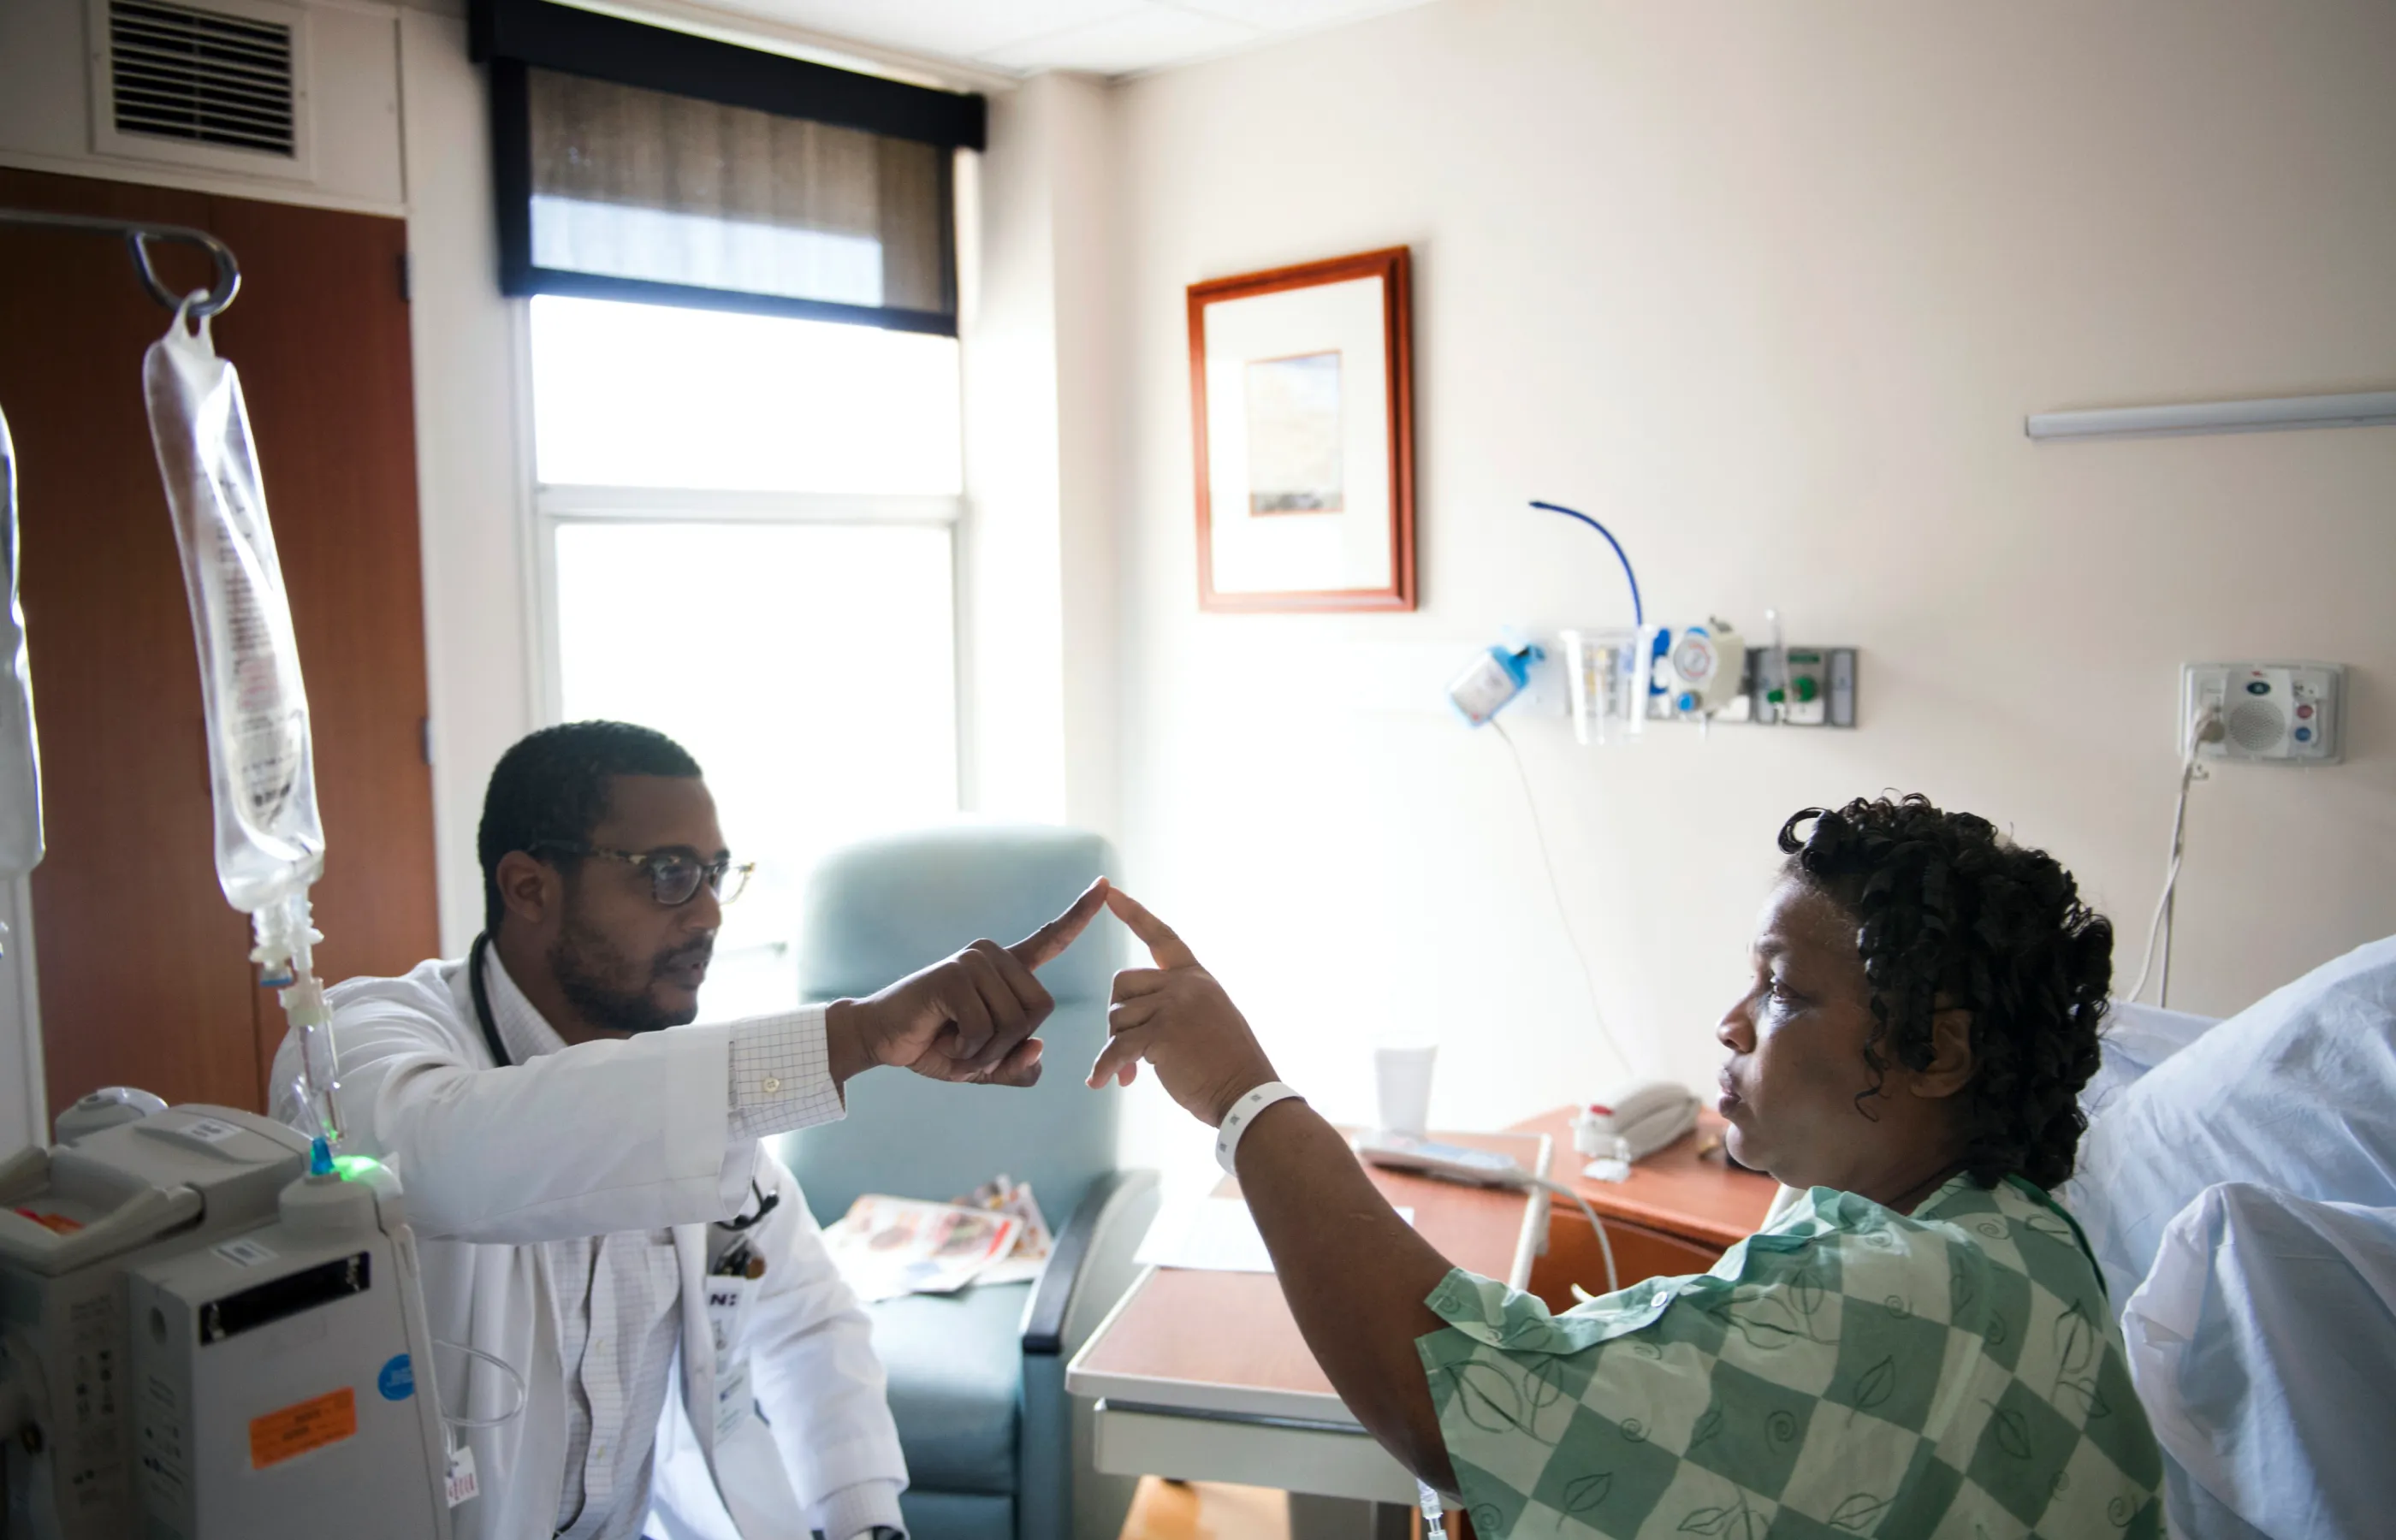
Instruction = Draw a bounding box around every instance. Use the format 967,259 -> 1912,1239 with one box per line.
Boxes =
0,1097 -> 450,1540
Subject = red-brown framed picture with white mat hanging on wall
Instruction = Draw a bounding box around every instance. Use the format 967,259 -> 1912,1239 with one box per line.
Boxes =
1191,246 -> 1414,611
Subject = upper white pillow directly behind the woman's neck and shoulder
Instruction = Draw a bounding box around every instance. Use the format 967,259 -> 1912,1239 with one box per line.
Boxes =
2063,937 -> 2396,1312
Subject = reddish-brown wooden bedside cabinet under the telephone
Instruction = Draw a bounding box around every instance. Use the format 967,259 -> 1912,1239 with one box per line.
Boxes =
1515,1106 -> 1780,1310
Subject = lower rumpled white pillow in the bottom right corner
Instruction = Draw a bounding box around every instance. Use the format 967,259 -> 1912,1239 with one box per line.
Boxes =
2120,1183 -> 2396,1540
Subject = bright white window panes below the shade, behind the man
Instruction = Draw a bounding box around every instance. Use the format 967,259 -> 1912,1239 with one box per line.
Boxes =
530,294 -> 961,1018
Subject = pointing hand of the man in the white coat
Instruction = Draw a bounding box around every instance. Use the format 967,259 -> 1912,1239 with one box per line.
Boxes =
824,877 -> 1107,1085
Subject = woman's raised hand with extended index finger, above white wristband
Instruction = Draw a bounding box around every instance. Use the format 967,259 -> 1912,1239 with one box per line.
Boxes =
1090,889 -> 1275,1128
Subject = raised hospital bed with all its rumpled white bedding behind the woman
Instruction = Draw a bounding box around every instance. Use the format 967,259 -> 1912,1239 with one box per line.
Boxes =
2063,937 -> 2396,1540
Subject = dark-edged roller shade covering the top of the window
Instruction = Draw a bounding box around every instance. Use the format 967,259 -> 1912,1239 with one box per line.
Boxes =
474,0 -> 982,335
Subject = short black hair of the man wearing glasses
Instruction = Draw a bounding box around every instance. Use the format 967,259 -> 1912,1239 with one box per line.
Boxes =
474,721 -> 700,937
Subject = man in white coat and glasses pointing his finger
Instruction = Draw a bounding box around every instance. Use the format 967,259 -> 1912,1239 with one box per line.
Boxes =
276,721 -> 1105,1540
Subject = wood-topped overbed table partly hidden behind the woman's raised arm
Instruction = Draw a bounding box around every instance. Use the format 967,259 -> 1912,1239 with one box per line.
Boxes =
1064,1133 -> 1552,1504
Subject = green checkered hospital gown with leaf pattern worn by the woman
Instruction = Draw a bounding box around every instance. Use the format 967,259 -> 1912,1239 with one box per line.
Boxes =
1416,1178 -> 2163,1540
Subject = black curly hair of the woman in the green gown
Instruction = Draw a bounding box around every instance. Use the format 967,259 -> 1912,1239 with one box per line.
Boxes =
1780,793 -> 2114,1188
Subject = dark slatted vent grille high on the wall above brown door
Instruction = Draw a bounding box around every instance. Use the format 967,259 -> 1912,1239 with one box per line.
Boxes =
108,0 -> 297,156
